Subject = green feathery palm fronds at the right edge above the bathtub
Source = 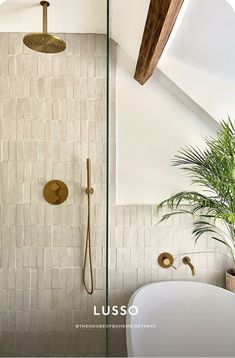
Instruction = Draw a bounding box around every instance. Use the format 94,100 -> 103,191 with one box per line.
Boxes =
157,118 -> 235,261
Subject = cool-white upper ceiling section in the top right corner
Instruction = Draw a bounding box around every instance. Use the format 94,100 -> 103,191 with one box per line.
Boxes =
168,0 -> 235,81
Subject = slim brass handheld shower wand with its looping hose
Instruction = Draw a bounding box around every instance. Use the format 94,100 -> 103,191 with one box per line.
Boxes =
82,159 -> 94,295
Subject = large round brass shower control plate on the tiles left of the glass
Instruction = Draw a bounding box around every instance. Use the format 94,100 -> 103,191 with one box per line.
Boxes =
43,180 -> 69,205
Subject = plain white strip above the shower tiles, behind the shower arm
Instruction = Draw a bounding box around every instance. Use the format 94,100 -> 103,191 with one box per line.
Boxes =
0,0 -> 106,33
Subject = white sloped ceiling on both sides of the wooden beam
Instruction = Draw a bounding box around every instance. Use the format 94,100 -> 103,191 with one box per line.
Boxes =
112,0 -> 235,121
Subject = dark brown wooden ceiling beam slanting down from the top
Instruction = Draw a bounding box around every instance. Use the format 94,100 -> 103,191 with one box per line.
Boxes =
134,0 -> 184,85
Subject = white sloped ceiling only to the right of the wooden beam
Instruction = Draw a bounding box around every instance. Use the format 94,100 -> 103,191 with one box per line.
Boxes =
158,0 -> 235,121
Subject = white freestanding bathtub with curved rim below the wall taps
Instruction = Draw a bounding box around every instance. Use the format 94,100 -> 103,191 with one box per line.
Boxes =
126,281 -> 235,357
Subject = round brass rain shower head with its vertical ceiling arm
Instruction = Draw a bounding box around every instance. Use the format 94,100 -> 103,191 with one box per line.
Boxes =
23,1 -> 66,53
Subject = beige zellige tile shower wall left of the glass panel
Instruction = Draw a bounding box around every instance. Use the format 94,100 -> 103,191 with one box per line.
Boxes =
0,33 -> 106,356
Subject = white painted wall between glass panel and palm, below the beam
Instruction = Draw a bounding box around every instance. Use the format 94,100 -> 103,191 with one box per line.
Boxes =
116,47 -> 218,205
